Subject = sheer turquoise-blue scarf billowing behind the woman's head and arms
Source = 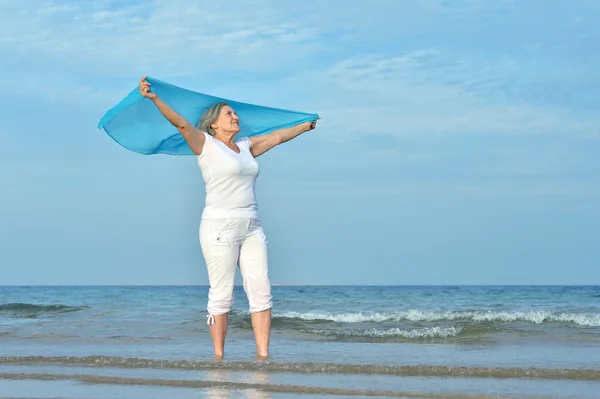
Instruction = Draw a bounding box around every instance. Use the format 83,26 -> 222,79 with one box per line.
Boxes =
98,77 -> 319,155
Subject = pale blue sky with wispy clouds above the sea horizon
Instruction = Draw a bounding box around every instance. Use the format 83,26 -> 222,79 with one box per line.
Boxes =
0,0 -> 600,285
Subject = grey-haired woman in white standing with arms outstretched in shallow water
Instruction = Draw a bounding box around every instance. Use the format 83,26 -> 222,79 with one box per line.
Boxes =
140,77 -> 316,359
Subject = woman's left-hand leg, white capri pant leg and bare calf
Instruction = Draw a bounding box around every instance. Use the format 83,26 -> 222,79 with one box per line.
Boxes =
200,220 -> 239,359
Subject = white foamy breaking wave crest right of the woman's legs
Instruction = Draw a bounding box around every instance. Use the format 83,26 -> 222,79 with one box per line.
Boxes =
273,309 -> 600,327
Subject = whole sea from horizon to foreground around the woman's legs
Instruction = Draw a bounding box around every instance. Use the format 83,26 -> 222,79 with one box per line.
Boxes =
0,286 -> 600,399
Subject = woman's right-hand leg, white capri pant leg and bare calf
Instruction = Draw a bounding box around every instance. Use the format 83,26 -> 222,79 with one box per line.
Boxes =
240,222 -> 273,359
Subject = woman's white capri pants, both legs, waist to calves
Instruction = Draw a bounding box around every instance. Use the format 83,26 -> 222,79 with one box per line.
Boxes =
200,219 -> 273,324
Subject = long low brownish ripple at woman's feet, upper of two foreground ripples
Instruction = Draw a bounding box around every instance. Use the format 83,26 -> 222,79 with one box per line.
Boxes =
0,356 -> 600,381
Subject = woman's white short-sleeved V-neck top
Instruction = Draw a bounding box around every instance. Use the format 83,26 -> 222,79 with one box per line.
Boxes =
197,133 -> 259,219
